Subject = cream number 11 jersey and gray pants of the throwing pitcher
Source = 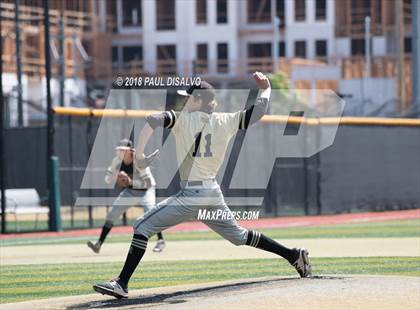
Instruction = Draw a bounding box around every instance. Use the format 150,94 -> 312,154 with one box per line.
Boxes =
134,98 -> 268,245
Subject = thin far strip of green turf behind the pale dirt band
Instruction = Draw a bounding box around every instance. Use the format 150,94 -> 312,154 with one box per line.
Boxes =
0,220 -> 420,246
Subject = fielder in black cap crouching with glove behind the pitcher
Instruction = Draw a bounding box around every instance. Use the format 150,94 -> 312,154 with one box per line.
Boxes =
87,139 -> 166,253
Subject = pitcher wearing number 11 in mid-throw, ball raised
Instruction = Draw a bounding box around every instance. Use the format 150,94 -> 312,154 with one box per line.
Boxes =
93,72 -> 311,298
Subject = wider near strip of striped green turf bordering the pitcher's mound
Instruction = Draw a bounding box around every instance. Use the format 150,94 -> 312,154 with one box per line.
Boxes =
0,257 -> 420,303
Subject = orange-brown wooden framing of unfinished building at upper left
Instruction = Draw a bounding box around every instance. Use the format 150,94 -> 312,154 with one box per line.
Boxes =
0,1 -> 115,79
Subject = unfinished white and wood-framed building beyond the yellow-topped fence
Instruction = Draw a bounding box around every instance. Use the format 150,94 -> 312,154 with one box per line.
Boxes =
0,0 -> 413,124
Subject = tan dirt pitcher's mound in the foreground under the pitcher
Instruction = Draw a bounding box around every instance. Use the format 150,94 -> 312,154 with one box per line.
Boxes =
1,276 -> 420,310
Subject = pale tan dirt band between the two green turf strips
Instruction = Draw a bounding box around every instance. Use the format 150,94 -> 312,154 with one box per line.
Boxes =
0,237 -> 420,265
